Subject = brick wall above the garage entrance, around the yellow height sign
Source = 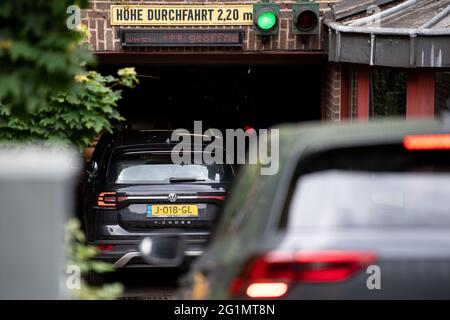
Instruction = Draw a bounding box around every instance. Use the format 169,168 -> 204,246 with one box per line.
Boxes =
82,0 -> 339,52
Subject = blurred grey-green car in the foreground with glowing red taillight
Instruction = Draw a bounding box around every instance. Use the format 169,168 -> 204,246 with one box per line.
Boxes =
147,120 -> 450,299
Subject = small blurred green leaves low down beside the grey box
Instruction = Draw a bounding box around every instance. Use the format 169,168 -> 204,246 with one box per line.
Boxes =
65,219 -> 123,300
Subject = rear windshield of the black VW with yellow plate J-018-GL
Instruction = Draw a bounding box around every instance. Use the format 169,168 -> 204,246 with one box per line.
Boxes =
108,153 -> 233,183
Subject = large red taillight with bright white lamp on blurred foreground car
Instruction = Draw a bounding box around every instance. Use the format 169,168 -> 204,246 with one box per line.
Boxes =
230,251 -> 375,298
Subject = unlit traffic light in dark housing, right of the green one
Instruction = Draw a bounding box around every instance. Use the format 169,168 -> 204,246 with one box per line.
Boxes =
292,1 -> 320,35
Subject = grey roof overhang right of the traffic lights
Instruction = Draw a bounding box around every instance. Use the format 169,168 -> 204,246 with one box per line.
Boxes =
324,0 -> 450,68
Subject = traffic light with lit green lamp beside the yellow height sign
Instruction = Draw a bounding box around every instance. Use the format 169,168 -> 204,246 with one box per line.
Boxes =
253,2 -> 280,36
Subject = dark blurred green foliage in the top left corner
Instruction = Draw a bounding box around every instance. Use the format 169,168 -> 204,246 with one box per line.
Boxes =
0,0 -> 93,113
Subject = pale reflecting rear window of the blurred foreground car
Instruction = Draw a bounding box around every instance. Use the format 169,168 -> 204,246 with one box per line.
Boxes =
282,146 -> 450,228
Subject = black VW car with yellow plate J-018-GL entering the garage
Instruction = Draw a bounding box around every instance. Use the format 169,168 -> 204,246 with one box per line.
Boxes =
83,131 -> 234,268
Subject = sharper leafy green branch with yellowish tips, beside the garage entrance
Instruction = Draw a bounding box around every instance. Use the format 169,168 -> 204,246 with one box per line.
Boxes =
0,68 -> 138,150
